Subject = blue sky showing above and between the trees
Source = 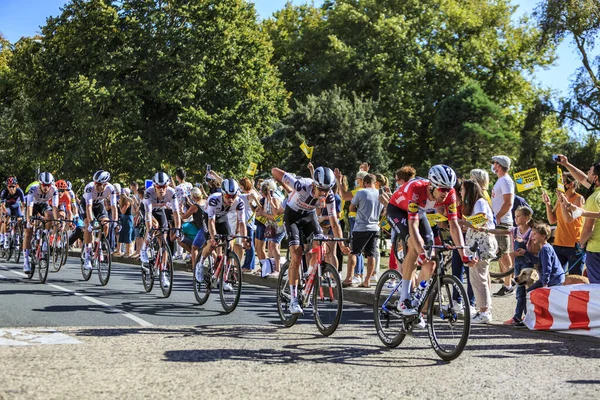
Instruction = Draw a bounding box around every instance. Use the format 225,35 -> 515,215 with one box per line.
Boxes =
0,0 -> 600,96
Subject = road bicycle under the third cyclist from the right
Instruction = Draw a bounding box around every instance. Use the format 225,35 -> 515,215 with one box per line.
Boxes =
193,235 -> 250,313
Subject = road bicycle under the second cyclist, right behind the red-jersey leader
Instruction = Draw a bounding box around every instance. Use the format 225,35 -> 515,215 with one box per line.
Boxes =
277,235 -> 348,336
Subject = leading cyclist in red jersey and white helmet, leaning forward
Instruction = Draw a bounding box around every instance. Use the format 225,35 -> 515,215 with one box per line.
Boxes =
387,164 -> 472,315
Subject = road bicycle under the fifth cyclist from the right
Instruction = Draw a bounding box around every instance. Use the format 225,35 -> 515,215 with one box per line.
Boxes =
80,219 -> 121,286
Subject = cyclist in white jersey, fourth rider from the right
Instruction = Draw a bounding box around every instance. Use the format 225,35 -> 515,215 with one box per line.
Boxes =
140,172 -> 181,288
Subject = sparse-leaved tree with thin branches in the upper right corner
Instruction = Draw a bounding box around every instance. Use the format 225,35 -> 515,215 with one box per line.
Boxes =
535,0 -> 600,134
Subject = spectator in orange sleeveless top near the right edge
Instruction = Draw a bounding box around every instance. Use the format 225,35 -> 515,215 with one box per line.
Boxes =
540,172 -> 585,275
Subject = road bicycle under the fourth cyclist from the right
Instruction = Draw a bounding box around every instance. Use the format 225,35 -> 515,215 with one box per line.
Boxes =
142,228 -> 181,298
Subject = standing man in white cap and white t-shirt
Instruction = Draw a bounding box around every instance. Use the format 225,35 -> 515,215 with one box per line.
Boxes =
492,156 -> 515,297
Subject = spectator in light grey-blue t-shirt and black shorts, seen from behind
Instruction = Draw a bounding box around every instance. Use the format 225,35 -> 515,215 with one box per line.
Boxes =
345,174 -> 383,288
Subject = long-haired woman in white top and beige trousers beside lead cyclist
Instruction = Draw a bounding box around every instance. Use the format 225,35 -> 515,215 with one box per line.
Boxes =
460,180 -> 498,324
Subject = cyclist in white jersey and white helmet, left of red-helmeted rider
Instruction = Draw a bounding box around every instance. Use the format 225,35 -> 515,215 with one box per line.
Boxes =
23,172 -> 58,274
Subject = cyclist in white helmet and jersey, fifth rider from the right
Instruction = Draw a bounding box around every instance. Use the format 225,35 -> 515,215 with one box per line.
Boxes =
82,170 -> 119,270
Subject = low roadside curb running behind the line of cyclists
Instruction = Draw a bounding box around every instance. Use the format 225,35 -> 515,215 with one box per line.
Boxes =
69,250 -> 375,306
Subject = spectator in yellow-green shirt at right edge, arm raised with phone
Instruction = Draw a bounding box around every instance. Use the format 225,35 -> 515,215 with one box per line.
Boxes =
557,154 -> 600,283
